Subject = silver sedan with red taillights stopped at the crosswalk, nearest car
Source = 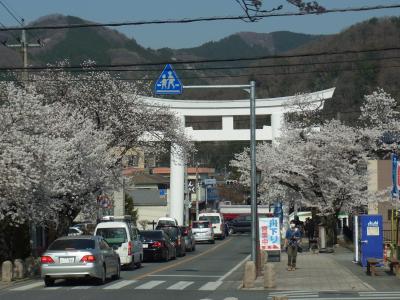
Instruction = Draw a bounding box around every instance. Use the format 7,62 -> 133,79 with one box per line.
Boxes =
41,235 -> 121,286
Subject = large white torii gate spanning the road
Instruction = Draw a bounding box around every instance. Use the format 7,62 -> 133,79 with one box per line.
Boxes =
143,88 -> 335,224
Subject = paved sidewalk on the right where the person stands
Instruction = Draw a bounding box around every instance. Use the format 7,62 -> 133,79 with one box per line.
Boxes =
250,247 -> 400,292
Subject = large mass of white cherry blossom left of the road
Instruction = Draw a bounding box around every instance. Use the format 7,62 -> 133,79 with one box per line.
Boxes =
0,66 -> 191,235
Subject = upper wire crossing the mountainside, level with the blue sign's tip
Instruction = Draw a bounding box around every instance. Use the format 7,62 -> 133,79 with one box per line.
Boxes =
0,47 -> 400,71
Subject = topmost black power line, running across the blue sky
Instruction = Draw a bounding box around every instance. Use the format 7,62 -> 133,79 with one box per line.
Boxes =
0,4 -> 400,31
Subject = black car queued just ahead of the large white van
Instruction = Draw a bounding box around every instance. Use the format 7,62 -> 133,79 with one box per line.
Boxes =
140,230 -> 176,261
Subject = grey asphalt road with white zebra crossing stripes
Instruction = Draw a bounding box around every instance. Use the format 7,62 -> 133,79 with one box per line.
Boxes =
0,235 -> 272,300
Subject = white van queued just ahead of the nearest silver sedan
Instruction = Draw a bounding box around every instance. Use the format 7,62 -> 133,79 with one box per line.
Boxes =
94,216 -> 143,268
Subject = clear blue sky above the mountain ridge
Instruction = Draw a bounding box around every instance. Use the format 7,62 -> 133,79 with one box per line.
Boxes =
0,0 -> 400,49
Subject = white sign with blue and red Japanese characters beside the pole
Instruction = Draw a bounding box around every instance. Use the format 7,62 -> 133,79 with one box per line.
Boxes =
258,218 -> 281,251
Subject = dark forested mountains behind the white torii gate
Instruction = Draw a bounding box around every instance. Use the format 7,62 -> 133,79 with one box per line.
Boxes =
0,15 -> 400,121
